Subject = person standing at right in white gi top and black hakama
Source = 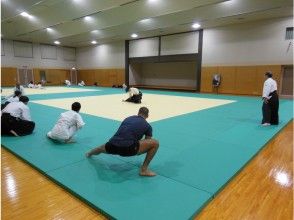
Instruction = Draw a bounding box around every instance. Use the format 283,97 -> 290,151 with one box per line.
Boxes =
261,72 -> 279,126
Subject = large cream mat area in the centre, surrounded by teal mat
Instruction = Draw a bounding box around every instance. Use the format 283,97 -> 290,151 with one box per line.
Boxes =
32,94 -> 235,122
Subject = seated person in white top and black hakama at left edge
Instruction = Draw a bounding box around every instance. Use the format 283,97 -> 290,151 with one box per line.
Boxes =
1,96 -> 35,136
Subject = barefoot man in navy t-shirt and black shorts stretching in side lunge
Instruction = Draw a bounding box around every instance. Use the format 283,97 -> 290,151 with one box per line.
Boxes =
86,107 -> 159,176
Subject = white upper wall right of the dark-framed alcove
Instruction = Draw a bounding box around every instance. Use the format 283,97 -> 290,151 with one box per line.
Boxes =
202,17 -> 293,66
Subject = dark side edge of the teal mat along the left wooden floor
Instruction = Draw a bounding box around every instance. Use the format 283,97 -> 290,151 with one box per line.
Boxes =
1,144 -> 116,220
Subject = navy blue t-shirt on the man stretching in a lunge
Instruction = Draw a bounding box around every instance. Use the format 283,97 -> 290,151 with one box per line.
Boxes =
109,115 -> 152,147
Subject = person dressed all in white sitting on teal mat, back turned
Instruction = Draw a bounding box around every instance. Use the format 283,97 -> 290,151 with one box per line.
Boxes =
47,102 -> 85,143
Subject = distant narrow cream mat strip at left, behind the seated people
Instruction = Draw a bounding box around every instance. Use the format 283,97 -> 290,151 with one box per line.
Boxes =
1,86 -> 99,96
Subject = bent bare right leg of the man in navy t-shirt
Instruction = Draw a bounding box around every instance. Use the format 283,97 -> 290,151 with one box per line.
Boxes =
138,139 -> 159,176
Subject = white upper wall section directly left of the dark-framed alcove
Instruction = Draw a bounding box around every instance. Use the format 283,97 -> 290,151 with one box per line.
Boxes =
77,41 -> 125,69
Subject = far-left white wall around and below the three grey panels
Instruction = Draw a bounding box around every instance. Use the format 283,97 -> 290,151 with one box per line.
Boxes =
1,40 -> 76,69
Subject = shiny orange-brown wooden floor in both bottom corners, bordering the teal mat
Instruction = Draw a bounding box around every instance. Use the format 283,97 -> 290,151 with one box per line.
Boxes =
1,122 -> 293,220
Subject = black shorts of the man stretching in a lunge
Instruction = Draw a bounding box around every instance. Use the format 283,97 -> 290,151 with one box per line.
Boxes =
105,141 -> 140,157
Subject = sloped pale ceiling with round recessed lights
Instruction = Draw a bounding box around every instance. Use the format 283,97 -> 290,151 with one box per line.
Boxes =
1,0 -> 293,47
